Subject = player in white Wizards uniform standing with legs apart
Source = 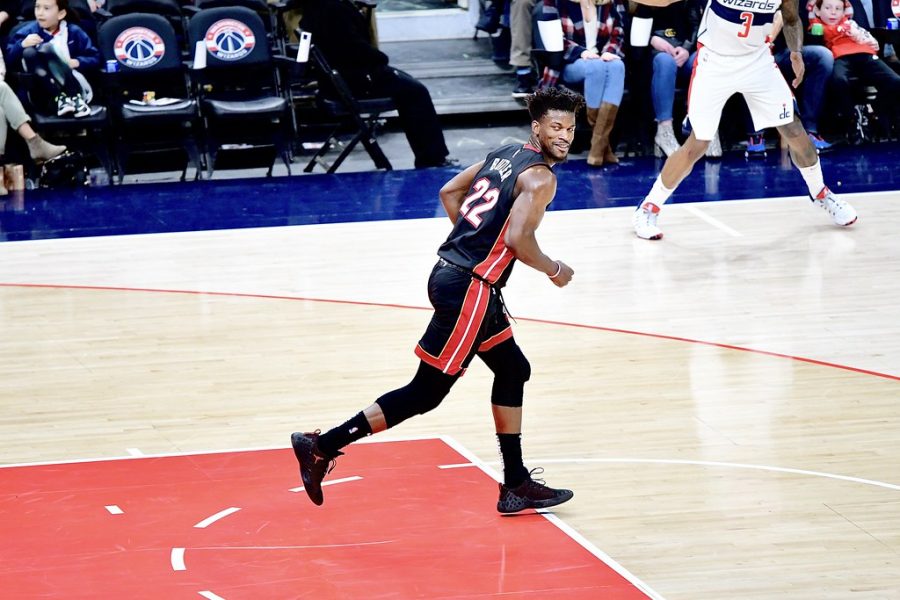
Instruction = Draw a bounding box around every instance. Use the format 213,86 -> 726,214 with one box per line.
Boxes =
633,0 -> 856,240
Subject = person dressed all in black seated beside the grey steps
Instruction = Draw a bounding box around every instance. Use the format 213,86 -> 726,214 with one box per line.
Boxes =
300,0 -> 454,169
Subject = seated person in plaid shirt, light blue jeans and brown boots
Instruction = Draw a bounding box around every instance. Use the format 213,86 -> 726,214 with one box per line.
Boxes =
541,0 -> 625,167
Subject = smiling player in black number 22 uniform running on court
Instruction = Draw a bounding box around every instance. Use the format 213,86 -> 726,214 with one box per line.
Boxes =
291,88 -> 584,513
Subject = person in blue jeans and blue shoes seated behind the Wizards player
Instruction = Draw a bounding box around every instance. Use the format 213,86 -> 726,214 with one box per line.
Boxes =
746,7 -> 834,154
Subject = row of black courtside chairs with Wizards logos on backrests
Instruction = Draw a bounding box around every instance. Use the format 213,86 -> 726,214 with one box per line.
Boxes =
11,6 -> 393,182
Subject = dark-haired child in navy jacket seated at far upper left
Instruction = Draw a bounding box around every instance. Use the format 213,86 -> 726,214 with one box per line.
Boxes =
7,0 -> 100,117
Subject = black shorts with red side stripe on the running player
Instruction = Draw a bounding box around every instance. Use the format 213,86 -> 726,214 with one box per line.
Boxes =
416,261 -> 512,375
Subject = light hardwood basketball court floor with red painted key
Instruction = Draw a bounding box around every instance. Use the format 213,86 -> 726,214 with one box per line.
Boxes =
0,182 -> 900,600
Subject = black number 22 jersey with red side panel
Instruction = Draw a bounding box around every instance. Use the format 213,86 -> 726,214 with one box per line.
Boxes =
438,144 -> 549,286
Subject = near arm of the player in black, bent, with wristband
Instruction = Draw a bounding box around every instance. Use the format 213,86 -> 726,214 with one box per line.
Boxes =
504,167 -> 574,287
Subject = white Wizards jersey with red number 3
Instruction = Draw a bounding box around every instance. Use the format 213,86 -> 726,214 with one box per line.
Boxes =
697,0 -> 781,56
